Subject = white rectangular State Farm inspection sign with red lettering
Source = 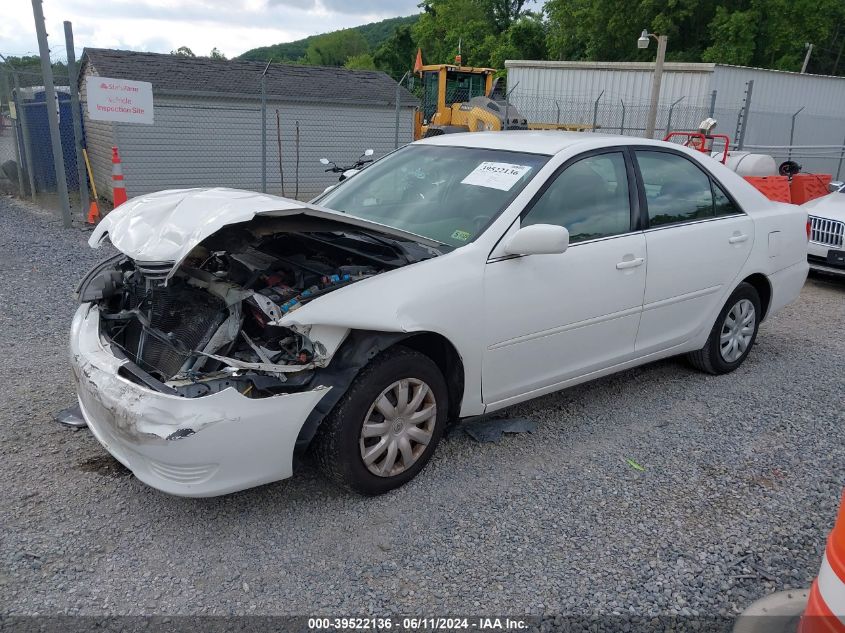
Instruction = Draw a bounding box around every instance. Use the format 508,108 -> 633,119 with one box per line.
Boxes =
86,75 -> 153,125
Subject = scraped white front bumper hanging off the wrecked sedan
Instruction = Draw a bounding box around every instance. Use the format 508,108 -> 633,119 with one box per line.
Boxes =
70,303 -> 330,497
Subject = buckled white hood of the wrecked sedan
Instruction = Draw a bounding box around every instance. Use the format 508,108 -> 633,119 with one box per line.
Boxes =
88,188 -> 438,274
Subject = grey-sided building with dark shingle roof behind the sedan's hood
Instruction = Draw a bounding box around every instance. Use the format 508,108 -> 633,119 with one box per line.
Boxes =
80,49 -> 417,200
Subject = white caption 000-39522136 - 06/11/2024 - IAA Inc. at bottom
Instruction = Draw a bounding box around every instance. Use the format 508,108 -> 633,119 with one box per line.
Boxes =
308,617 -> 528,631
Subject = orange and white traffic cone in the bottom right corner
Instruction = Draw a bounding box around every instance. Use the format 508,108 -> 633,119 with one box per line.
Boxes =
798,495 -> 845,633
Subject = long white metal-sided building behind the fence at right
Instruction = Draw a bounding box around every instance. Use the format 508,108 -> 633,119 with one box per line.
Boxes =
505,60 -> 845,173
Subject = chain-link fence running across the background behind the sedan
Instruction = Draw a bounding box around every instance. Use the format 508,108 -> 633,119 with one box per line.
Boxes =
0,55 -> 845,226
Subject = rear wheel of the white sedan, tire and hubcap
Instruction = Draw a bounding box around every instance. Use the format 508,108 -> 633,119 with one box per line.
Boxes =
688,282 -> 763,374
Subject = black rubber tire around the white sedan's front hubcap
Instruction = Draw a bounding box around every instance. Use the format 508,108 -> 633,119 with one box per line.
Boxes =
312,345 -> 449,496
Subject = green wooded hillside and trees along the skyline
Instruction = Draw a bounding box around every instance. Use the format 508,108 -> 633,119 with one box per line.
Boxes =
232,0 -> 845,79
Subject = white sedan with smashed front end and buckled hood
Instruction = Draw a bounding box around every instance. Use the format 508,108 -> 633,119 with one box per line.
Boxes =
70,131 -> 807,496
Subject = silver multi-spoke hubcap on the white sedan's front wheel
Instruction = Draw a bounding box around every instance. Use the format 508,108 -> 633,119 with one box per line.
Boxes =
359,378 -> 437,477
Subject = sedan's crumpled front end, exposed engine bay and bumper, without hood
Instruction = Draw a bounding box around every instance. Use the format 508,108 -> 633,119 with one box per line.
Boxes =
71,200 -> 436,496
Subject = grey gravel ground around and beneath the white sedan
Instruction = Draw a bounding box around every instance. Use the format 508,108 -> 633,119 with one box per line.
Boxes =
0,198 -> 845,616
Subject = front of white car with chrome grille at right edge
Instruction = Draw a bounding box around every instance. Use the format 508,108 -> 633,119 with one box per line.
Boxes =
803,182 -> 845,275
